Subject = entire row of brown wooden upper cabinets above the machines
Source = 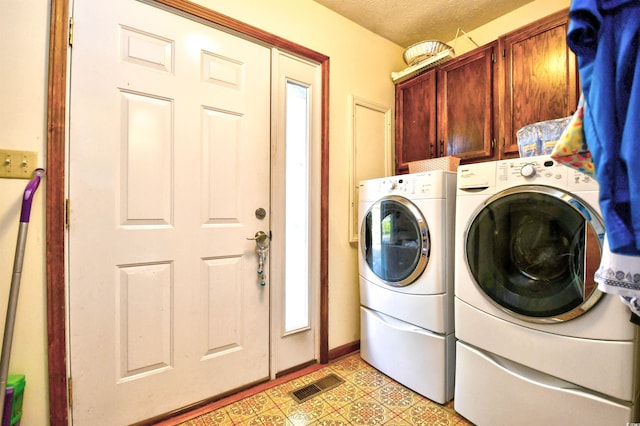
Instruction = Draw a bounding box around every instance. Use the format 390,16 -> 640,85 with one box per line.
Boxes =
396,10 -> 580,173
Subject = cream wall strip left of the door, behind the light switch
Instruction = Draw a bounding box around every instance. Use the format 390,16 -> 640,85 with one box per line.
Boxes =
0,0 -> 49,426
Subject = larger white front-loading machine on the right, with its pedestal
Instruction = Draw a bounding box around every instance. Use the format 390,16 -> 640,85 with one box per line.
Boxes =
455,156 -> 640,426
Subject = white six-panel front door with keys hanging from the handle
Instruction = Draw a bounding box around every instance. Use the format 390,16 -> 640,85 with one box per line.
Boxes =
68,0 -> 270,425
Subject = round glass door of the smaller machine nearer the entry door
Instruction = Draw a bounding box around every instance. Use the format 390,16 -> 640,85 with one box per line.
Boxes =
360,196 -> 430,287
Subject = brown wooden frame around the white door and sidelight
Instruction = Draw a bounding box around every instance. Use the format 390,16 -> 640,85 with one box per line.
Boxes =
45,0 -> 329,426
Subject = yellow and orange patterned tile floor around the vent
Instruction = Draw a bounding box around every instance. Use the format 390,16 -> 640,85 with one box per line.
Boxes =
169,353 -> 471,426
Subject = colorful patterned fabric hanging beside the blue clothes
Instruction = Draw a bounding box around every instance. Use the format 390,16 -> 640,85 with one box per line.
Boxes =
551,97 -> 595,176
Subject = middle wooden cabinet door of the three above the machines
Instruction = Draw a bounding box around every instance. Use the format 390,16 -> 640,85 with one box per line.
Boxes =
438,42 -> 497,162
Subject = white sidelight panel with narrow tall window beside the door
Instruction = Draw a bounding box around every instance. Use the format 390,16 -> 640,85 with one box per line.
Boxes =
270,50 -> 322,375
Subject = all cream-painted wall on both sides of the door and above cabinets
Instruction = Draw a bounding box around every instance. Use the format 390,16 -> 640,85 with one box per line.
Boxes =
0,0 -> 569,426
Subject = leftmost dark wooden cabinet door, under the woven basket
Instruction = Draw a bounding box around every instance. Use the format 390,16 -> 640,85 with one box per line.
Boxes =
396,70 -> 436,173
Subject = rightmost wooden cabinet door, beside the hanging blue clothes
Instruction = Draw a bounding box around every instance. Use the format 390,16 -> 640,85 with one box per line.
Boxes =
500,10 -> 579,158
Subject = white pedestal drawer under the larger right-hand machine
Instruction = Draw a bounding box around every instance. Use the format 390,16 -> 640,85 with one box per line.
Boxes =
455,342 -> 632,426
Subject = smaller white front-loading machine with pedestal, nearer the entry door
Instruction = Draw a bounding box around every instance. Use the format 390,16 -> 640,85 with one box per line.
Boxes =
358,171 -> 456,403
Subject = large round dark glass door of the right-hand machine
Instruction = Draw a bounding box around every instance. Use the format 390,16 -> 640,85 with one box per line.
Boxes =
465,186 -> 604,322
